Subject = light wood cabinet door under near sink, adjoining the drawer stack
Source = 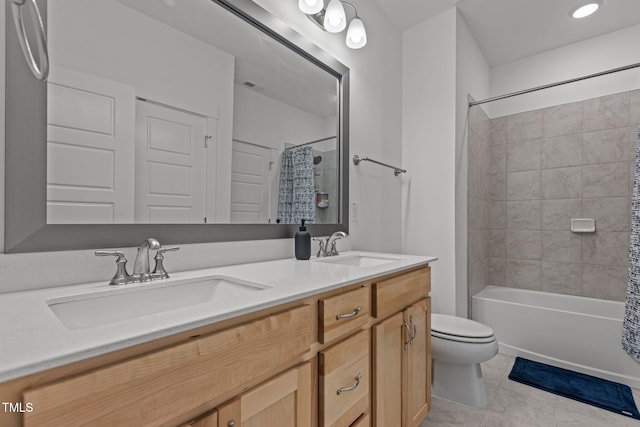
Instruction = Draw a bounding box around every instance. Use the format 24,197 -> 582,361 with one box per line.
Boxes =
218,362 -> 312,427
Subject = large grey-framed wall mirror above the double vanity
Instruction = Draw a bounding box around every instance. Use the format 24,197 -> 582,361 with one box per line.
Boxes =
5,0 -> 348,252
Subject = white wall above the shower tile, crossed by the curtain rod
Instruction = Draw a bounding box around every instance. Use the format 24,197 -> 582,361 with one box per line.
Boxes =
488,25 -> 640,117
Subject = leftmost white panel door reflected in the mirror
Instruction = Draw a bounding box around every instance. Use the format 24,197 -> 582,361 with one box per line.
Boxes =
47,68 -> 135,224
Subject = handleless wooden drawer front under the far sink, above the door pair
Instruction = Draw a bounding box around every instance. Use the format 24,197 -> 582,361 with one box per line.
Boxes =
372,267 -> 431,319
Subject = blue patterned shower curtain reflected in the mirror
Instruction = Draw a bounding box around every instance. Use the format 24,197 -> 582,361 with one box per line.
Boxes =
278,146 -> 316,224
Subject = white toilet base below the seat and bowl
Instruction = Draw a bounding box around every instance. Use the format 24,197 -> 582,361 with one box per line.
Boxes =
431,360 -> 487,408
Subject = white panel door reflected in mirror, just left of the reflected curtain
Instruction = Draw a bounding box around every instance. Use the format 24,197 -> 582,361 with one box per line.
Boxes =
231,140 -> 272,224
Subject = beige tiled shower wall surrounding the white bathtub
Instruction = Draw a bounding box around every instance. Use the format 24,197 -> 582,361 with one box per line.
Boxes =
480,90 -> 640,301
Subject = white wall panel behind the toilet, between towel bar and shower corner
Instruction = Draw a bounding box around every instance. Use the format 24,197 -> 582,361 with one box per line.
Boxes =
402,9 -> 457,314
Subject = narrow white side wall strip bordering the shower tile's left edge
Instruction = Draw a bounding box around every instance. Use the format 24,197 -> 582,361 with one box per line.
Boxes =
455,12 -> 490,317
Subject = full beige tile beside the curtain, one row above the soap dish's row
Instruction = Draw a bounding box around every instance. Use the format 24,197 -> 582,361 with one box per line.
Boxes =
582,162 -> 629,198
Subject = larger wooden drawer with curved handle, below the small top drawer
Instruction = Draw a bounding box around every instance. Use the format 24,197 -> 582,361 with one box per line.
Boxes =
319,330 -> 370,427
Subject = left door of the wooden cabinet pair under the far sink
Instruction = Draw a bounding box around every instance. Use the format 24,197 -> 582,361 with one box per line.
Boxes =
373,313 -> 405,427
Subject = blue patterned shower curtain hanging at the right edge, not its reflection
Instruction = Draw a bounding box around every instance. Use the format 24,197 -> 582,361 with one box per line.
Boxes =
622,124 -> 640,361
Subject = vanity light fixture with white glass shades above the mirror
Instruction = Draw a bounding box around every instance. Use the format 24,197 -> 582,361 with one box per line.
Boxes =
298,0 -> 367,49
